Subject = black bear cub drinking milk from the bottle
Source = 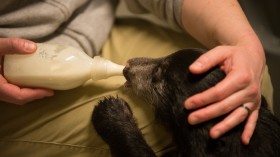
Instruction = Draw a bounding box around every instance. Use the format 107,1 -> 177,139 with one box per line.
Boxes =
92,49 -> 280,157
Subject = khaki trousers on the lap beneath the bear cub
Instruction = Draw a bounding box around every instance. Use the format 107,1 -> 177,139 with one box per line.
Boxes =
0,19 -> 271,157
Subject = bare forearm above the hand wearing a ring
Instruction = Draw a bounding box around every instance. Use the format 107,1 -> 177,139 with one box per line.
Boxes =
182,0 -> 262,53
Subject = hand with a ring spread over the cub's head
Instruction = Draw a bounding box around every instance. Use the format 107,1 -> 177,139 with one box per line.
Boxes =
185,46 -> 265,144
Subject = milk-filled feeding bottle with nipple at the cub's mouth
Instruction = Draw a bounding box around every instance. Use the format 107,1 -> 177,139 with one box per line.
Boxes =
3,43 -> 124,90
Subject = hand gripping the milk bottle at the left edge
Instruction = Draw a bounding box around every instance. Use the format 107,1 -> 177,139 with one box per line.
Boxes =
0,38 -> 53,105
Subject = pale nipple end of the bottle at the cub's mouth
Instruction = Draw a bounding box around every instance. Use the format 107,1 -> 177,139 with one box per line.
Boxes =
91,56 -> 124,80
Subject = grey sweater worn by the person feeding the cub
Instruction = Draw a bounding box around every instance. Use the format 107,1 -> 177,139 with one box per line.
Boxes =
0,0 -> 183,56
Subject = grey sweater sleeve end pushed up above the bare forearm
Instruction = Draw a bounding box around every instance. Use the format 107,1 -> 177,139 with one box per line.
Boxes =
125,0 -> 183,29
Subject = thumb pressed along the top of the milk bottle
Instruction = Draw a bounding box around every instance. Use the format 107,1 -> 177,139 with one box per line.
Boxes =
0,38 -> 36,55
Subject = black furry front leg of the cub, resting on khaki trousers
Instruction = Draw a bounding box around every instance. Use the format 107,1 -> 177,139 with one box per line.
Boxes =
92,97 -> 156,157
